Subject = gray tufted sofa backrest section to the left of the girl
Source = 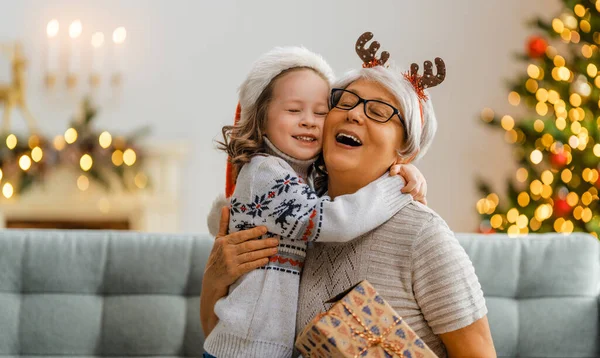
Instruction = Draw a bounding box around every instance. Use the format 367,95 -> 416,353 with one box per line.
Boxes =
0,230 -> 212,357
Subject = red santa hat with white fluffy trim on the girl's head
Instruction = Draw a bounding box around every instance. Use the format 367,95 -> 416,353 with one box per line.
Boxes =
225,46 -> 335,198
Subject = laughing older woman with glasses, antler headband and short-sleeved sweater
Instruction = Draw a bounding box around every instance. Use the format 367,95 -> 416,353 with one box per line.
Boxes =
201,35 -> 496,358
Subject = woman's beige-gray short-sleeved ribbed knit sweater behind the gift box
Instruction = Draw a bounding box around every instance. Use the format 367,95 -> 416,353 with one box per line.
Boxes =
297,198 -> 487,358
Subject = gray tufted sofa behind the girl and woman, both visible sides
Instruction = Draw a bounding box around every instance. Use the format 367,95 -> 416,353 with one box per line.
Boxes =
0,230 -> 600,358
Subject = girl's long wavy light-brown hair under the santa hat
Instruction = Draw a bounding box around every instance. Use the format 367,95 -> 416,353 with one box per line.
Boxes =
217,67 -> 329,176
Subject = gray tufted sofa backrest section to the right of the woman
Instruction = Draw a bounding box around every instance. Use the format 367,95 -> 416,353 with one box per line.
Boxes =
457,234 -> 600,358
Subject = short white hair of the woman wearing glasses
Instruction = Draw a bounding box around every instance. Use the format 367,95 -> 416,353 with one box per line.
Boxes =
333,66 -> 437,161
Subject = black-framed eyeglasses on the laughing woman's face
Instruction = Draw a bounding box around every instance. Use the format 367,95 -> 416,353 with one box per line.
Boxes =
330,88 -> 406,128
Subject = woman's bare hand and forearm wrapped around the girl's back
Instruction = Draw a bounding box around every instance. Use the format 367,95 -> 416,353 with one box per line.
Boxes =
200,207 -> 279,336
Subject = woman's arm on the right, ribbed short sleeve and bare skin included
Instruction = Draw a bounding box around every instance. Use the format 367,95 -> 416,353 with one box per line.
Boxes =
411,215 -> 496,357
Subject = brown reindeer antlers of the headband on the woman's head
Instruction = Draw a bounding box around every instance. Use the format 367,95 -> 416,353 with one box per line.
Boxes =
356,32 -> 446,101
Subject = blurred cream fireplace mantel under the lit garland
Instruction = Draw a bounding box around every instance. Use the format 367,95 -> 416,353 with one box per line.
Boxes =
0,142 -> 188,232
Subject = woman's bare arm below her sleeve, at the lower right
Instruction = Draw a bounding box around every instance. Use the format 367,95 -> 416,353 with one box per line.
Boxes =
440,316 -> 496,358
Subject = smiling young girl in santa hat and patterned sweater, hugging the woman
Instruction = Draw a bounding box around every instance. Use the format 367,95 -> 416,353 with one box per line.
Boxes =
204,47 -> 426,358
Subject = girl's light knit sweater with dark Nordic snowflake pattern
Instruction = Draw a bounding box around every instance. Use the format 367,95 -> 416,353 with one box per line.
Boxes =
204,138 -> 406,358
